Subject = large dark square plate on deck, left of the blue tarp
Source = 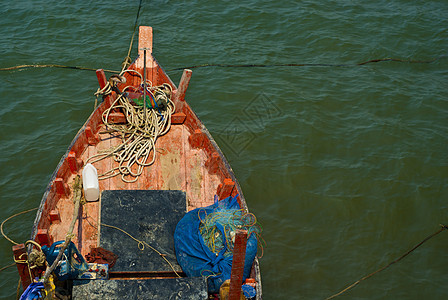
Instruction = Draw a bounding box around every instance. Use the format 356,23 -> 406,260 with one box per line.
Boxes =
100,190 -> 186,272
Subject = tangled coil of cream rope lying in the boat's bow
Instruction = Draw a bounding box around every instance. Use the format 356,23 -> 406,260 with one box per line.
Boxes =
86,69 -> 175,183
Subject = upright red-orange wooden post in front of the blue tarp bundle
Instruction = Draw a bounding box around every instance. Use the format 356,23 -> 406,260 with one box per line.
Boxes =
229,229 -> 247,300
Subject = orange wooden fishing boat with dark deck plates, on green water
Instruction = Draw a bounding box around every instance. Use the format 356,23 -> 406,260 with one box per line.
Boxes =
15,26 -> 262,299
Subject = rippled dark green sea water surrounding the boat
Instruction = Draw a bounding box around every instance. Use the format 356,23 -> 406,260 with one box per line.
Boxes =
0,0 -> 448,299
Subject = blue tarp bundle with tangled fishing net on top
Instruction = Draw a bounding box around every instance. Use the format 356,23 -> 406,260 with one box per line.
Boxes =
174,196 -> 261,293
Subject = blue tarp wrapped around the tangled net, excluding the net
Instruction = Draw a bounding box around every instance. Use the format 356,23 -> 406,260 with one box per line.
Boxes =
174,196 -> 257,293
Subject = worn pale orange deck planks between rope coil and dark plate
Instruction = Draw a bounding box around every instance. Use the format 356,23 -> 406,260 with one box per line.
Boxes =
49,121 -> 221,255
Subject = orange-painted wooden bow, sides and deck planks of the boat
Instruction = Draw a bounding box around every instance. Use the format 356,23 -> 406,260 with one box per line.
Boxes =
28,26 -> 261,299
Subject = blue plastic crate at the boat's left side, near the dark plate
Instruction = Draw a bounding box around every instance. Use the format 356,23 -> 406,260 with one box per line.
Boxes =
42,241 -> 88,281
